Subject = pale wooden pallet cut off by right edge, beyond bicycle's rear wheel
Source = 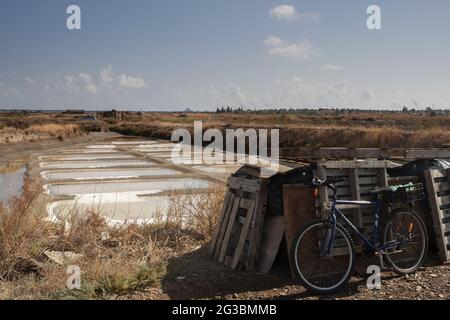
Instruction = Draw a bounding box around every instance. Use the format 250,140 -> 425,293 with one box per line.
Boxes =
424,169 -> 450,262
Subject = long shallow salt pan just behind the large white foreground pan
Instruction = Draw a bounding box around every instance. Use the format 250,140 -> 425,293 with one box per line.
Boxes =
44,178 -> 210,196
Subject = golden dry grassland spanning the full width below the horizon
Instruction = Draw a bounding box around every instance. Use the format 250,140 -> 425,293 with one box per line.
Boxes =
0,110 -> 450,148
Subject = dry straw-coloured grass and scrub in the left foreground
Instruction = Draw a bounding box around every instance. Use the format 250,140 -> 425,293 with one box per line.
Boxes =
0,181 -> 223,299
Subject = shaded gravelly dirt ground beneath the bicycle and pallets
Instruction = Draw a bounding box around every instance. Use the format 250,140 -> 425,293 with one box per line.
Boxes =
122,248 -> 450,300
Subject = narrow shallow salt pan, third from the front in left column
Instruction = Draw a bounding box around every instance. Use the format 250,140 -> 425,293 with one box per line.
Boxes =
41,167 -> 182,180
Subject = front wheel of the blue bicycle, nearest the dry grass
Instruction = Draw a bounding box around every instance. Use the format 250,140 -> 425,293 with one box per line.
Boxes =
290,220 -> 355,294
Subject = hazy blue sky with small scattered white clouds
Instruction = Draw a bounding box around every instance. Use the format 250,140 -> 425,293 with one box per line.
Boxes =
0,0 -> 450,111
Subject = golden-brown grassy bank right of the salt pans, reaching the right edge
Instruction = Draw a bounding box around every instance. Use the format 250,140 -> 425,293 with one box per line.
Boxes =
110,112 -> 450,148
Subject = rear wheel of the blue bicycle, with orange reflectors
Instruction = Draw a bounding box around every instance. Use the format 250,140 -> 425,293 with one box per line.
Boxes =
383,209 -> 428,274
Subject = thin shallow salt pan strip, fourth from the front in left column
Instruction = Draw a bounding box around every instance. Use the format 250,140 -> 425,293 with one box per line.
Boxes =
40,160 -> 155,169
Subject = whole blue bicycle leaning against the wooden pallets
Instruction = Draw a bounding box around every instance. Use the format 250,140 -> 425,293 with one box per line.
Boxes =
290,177 -> 428,294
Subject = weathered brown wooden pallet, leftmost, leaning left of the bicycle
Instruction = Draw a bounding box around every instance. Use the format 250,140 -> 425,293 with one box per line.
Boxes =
209,176 -> 267,270
